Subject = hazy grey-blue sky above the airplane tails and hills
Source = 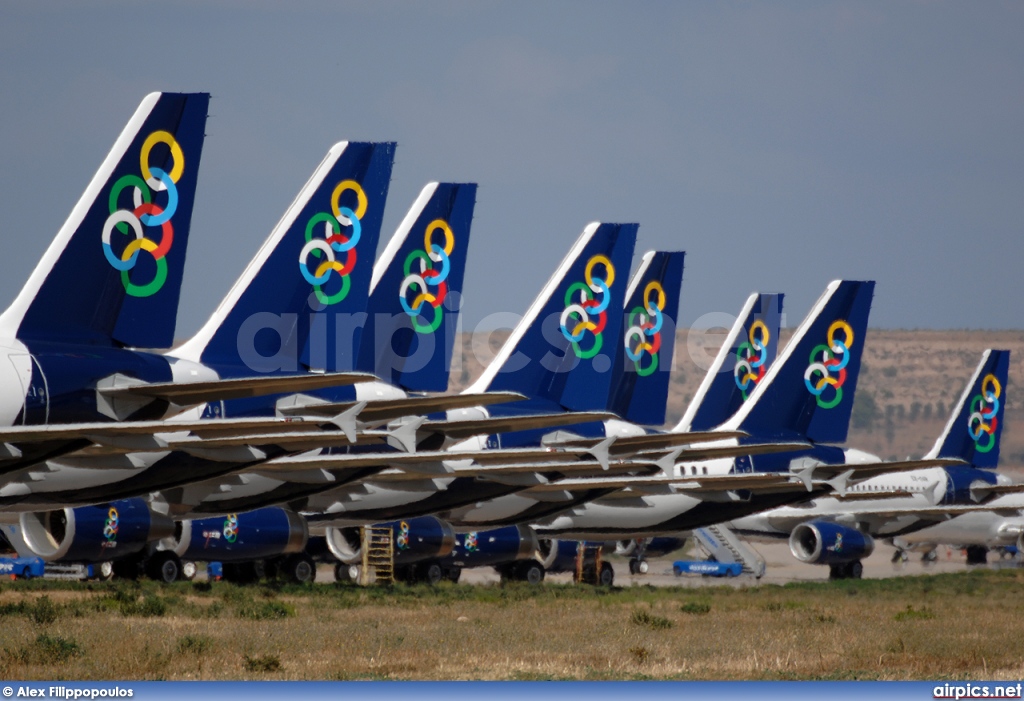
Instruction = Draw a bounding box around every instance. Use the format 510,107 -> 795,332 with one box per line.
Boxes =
0,0 -> 1024,336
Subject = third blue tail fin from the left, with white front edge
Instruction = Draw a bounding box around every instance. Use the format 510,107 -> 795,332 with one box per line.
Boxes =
356,182 -> 476,392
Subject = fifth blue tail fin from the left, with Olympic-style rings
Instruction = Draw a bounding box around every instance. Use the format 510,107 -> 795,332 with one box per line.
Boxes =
608,251 -> 686,426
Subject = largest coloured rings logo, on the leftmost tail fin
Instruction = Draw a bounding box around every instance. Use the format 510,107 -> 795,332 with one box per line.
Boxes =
102,131 -> 185,297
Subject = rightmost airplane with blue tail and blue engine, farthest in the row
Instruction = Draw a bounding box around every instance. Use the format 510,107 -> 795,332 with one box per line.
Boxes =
728,350 -> 1024,579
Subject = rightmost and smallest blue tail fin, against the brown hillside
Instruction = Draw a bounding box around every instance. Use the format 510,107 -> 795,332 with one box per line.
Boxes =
927,350 -> 1010,470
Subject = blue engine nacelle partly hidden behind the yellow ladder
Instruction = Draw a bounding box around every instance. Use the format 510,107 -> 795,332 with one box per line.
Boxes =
325,516 -> 455,565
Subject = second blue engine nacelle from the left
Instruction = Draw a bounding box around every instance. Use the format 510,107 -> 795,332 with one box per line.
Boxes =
165,507 -> 309,562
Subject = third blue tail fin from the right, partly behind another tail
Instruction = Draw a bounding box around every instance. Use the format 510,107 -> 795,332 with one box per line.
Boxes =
673,294 -> 783,433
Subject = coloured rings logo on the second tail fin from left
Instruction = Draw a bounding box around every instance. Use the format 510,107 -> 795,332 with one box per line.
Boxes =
299,180 -> 369,306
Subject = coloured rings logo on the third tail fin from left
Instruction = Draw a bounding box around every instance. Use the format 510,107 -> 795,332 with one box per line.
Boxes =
398,219 -> 455,334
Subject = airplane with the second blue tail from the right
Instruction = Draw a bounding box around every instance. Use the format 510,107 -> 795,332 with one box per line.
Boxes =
531,280 -> 956,540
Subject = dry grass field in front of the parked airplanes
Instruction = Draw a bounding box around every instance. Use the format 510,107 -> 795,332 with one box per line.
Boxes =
0,570 -> 1024,680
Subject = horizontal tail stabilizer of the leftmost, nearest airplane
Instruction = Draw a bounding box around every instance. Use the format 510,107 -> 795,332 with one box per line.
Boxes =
96,373 -> 377,406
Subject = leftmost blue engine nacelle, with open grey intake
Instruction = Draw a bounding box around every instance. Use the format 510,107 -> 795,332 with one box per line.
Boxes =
18,498 -> 174,563
